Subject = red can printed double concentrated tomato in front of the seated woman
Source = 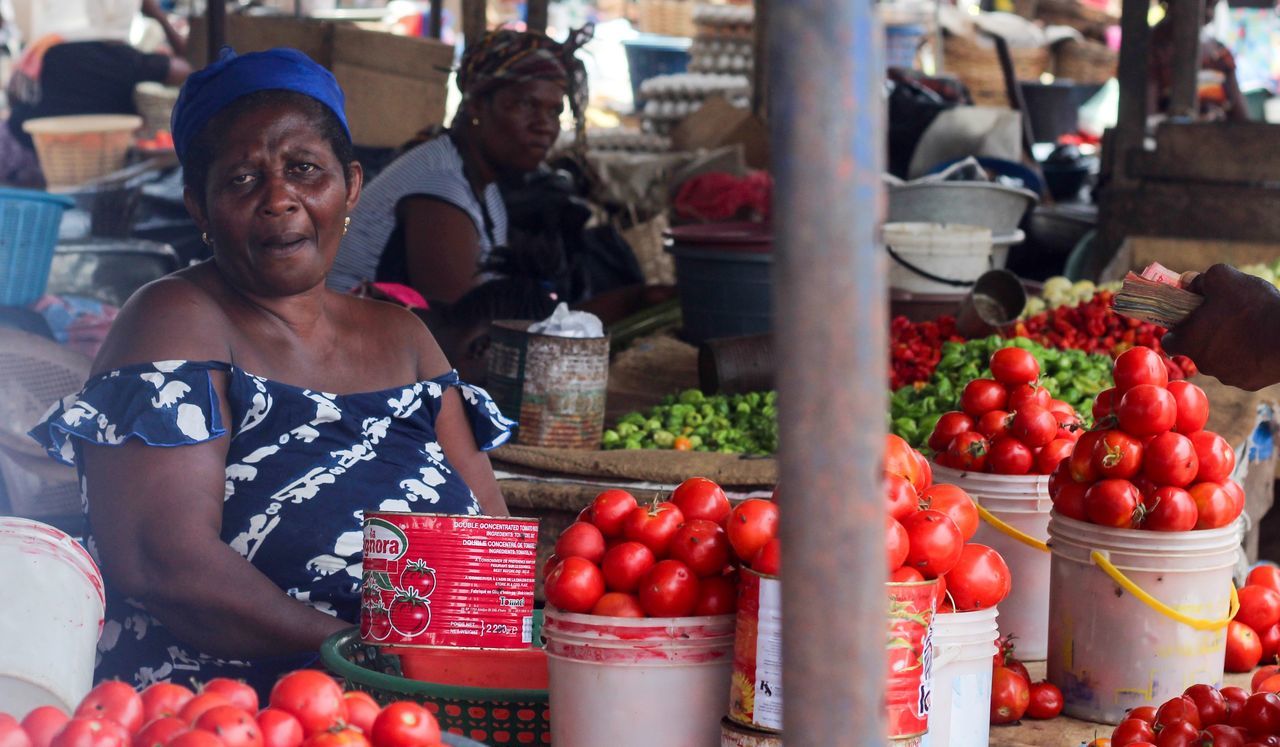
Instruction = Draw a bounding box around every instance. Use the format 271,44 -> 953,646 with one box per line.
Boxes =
360,512 -> 538,649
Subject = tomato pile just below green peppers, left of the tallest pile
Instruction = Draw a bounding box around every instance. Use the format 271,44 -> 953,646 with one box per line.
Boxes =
929,348 -> 1080,475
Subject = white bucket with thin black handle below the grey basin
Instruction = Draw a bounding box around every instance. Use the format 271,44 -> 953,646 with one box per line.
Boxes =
884,223 -> 992,293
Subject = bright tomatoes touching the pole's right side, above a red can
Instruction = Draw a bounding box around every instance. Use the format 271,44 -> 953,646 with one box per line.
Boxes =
884,434 -> 1012,611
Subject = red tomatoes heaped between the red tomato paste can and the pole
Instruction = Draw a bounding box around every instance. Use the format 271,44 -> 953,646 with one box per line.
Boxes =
544,477 -> 782,618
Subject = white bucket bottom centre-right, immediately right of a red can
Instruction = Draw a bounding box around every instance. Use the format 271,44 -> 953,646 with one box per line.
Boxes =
922,608 -> 997,747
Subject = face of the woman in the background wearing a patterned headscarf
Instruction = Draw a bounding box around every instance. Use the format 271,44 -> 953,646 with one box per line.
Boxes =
475,81 -> 564,173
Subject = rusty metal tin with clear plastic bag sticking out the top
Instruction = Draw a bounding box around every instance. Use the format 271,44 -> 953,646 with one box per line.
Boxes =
488,321 -> 609,449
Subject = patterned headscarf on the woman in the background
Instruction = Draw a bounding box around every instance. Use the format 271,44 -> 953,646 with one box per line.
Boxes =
458,24 -> 595,142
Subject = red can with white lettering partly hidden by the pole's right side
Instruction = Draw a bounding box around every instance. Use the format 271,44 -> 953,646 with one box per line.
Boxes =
884,579 -> 938,746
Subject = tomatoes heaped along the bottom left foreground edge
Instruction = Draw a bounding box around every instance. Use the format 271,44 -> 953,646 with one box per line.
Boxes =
0,669 -> 443,747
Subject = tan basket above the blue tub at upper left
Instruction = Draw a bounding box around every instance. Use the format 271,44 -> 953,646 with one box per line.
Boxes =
22,114 -> 142,191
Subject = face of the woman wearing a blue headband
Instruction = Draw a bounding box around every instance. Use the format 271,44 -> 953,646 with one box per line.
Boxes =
186,104 -> 362,298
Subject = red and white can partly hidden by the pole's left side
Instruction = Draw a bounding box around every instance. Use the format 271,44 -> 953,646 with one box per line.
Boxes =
728,568 -> 782,733
